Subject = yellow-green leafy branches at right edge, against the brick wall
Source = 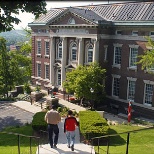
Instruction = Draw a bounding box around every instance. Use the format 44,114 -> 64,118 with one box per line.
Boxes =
137,37 -> 154,73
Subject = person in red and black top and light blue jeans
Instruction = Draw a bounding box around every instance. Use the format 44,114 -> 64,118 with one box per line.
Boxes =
64,110 -> 78,151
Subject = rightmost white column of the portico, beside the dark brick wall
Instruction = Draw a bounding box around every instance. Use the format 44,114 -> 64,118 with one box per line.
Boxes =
93,39 -> 99,62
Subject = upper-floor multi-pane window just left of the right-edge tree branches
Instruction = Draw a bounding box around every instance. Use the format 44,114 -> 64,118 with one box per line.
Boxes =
129,48 -> 138,67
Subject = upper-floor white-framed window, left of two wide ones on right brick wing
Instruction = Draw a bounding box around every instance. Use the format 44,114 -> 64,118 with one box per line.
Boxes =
113,44 -> 122,68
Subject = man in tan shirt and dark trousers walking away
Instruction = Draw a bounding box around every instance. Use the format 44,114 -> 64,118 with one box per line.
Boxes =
44,105 -> 61,148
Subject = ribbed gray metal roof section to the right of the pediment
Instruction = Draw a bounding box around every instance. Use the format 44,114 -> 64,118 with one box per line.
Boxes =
89,2 -> 154,21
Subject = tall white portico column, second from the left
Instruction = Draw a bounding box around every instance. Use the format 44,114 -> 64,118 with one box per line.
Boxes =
61,37 -> 67,87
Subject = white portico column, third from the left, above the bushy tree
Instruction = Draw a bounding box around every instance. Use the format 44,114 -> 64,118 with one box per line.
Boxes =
78,38 -> 84,65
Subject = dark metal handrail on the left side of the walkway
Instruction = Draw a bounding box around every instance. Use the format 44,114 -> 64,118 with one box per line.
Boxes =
0,131 -> 40,154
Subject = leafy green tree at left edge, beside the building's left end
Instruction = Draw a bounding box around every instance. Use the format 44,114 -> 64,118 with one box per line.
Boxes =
0,37 -> 32,96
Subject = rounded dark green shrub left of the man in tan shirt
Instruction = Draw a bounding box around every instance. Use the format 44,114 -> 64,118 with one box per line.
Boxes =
32,112 -> 47,132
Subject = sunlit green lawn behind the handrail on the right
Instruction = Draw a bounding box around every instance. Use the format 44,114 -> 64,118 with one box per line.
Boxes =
95,125 -> 154,154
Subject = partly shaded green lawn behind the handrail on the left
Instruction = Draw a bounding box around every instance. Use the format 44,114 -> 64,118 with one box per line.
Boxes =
0,125 -> 37,154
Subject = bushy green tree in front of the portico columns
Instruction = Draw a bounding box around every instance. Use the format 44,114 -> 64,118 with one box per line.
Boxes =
63,62 -> 106,108
